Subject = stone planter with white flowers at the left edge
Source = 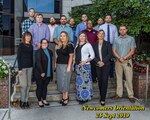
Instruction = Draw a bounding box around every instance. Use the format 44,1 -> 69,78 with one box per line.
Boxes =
0,57 -> 10,108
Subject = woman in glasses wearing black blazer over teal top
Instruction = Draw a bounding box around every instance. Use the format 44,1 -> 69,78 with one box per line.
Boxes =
35,38 -> 53,107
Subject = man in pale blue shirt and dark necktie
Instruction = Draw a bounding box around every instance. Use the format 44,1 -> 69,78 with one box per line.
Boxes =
99,15 -> 118,80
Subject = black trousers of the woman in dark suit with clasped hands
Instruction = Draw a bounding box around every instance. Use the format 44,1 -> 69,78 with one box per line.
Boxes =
96,64 -> 110,101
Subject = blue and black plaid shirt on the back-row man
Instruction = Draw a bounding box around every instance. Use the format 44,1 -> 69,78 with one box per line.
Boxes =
22,18 -> 36,34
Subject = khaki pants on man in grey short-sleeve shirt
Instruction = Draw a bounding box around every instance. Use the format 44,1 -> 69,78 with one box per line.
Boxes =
115,60 -> 134,98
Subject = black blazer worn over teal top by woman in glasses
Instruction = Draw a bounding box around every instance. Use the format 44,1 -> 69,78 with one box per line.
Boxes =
35,48 -> 53,79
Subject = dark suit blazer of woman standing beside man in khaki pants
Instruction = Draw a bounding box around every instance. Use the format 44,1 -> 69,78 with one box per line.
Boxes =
93,40 -> 112,65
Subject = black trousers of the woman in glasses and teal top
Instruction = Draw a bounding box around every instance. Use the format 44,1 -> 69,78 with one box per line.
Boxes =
36,78 -> 50,101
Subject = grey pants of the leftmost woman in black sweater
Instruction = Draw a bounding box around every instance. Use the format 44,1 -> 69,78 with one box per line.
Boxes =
19,67 -> 32,102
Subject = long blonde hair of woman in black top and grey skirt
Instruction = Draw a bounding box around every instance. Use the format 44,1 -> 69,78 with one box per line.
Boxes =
56,31 -> 72,49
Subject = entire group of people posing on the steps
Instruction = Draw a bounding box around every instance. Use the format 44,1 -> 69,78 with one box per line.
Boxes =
17,8 -> 136,108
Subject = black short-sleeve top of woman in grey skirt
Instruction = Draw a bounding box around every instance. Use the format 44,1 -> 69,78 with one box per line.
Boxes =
56,44 -> 74,64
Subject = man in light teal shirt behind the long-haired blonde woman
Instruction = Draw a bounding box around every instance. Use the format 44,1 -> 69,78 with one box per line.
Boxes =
53,15 -> 73,44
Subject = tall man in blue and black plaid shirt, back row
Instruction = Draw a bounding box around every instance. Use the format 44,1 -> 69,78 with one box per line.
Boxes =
21,8 -> 36,35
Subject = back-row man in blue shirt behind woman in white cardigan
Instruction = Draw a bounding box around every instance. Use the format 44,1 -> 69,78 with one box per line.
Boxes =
75,14 -> 88,38
